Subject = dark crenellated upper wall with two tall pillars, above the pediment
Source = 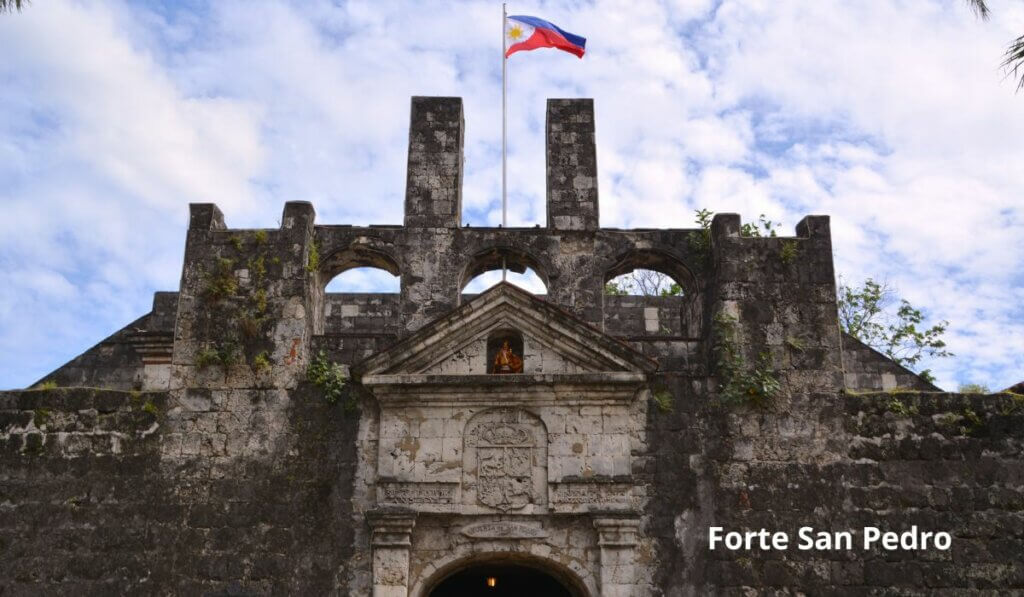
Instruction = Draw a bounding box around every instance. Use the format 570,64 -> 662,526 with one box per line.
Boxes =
59,97 -> 842,395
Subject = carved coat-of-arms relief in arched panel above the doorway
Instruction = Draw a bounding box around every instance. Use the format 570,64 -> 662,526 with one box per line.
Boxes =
463,409 -> 548,512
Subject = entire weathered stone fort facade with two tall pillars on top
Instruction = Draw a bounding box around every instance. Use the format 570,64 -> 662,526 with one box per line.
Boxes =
0,97 -> 1024,597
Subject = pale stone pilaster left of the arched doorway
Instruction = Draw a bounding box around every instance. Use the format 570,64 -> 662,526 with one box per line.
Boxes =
367,510 -> 416,597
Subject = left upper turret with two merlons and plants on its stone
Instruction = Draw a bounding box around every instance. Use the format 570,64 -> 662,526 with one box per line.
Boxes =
169,202 -> 323,390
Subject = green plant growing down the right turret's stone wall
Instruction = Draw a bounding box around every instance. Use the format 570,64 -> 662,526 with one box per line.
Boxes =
714,311 -> 782,409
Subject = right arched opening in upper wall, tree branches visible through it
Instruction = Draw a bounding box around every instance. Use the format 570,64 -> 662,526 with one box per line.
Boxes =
604,250 -> 701,338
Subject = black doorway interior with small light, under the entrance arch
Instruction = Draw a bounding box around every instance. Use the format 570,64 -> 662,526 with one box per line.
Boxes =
429,564 -> 575,597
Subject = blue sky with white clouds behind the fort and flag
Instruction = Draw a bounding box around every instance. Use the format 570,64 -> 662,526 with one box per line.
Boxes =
0,0 -> 1024,389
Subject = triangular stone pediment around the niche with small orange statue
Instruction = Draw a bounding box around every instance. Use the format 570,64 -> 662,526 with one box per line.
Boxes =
354,283 -> 657,377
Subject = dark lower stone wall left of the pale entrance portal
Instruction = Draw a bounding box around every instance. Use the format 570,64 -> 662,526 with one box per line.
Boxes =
0,388 -> 359,595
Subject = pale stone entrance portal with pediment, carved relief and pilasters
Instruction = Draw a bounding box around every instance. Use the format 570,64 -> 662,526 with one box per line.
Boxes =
354,284 -> 656,597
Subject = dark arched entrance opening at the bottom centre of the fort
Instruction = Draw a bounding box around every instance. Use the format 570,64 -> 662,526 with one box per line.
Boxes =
424,559 -> 587,597
